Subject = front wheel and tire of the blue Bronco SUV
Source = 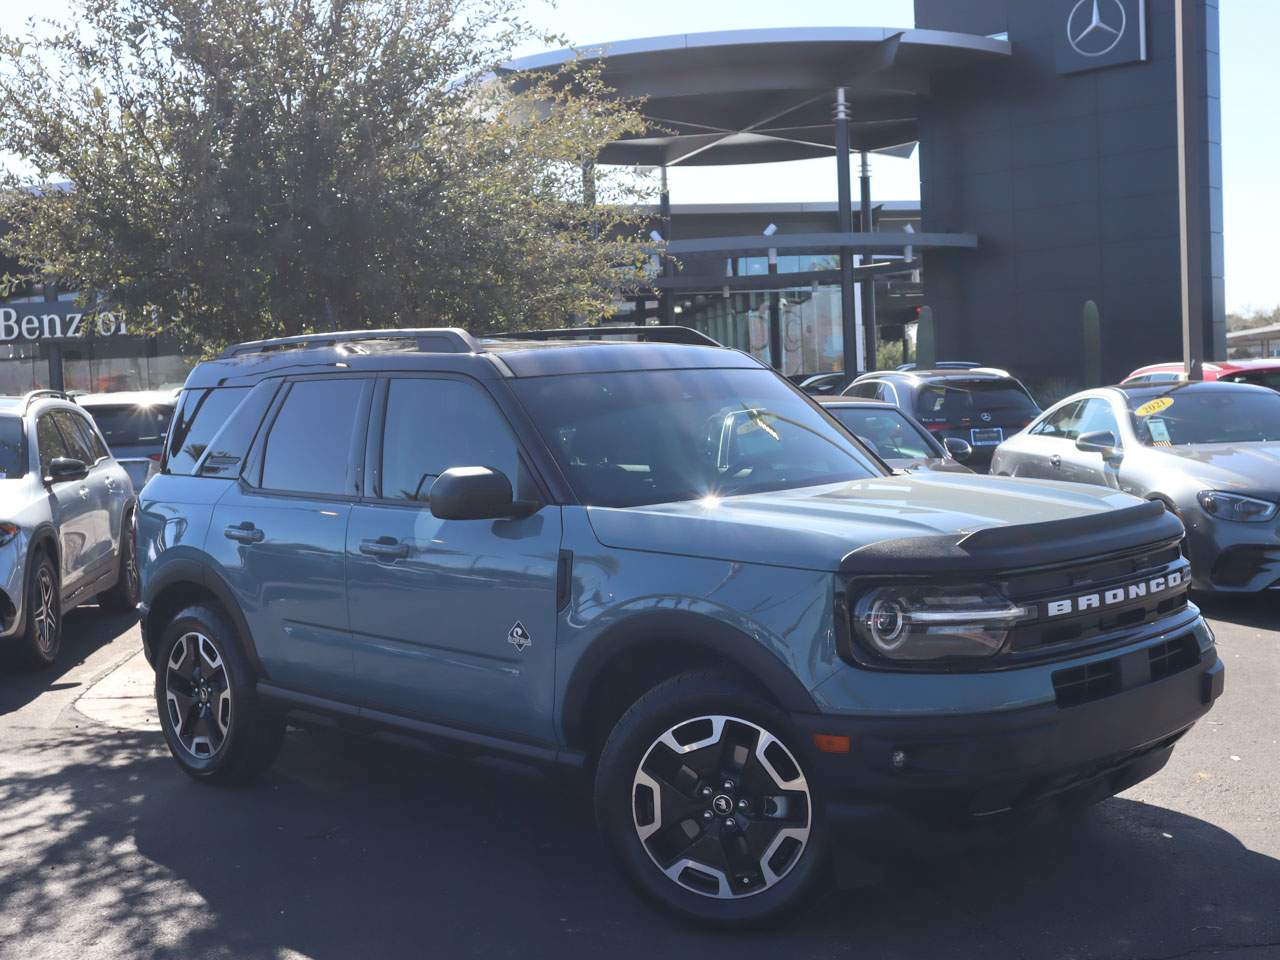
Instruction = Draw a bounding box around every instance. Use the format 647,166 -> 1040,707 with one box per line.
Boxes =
595,671 -> 827,927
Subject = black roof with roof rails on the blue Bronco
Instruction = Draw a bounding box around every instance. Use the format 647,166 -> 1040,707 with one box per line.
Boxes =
187,328 -> 764,387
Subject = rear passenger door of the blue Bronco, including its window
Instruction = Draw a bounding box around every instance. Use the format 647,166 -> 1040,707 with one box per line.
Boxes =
206,376 -> 374,704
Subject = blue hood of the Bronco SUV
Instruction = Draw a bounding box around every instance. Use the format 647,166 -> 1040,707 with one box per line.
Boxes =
588,474 -> 1162,571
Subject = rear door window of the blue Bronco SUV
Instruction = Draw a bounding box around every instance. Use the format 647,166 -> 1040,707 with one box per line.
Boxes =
262,378 -> 363,495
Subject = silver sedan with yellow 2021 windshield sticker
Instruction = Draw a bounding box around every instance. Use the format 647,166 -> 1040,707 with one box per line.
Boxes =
991,381 -> 1280,593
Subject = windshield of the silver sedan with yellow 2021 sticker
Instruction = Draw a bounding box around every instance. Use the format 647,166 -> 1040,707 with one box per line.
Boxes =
1129,387 -> 1280,447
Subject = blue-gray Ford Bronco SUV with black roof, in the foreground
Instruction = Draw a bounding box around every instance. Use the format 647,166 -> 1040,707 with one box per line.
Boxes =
138,328 -> 1222,923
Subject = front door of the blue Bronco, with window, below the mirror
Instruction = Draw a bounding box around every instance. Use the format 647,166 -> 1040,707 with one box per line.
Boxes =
347,376 -> 561,742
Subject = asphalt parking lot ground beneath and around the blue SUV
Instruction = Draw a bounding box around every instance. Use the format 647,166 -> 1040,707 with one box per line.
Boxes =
0,595 -> 1280,960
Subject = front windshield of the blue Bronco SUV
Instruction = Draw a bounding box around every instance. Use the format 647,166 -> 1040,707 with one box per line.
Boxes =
512,370 -> 883,507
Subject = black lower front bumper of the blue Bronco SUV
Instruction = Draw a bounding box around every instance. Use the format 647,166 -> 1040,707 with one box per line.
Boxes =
795,620 -> 1224,837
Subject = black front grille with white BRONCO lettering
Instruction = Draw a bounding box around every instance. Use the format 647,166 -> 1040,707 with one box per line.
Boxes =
1001,544 -> 1190,659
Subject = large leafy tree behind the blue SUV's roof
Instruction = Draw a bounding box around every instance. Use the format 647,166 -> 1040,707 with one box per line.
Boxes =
0,0 -> 645,349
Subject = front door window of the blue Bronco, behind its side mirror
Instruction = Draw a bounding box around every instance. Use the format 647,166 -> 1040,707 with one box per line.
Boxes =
379,378 -> 522,502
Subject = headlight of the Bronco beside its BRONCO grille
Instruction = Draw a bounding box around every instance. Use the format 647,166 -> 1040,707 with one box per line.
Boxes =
854,585 -> 1034,660
